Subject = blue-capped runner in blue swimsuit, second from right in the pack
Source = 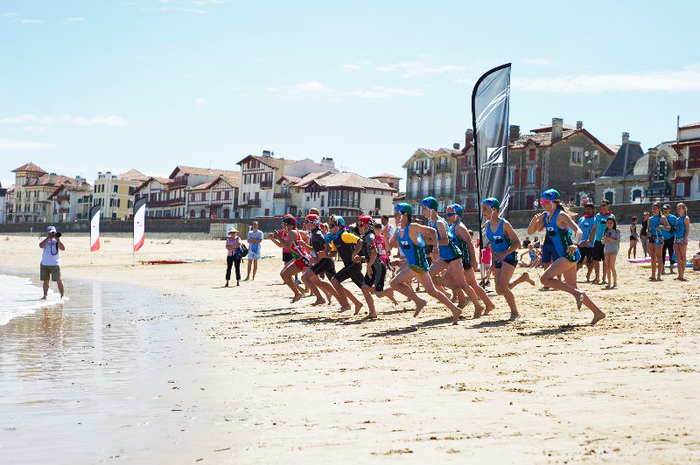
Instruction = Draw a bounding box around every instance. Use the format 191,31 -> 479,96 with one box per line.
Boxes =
481,197 -> 535,321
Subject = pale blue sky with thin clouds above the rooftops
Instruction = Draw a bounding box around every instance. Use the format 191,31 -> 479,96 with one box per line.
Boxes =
0,0 -> 700,187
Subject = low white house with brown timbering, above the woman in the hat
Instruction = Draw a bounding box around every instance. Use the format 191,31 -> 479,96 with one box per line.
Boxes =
185,173 -> 240,220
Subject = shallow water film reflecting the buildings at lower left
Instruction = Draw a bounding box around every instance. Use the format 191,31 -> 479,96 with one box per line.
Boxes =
0,276 -> 250,463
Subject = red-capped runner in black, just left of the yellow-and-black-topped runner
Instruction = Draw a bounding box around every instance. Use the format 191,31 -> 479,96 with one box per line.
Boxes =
301,213 -> 337,305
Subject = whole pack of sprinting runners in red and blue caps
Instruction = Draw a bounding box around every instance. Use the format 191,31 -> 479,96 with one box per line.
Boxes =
269,189 -> 616,325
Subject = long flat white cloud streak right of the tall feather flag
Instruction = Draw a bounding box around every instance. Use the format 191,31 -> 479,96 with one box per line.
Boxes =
513,66 -> 700,93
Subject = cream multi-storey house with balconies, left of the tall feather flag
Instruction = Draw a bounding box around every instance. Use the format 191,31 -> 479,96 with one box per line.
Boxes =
403,144 -> 462,211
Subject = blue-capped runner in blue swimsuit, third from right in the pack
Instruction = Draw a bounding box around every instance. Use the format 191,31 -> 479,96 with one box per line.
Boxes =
447,203 -> 496,318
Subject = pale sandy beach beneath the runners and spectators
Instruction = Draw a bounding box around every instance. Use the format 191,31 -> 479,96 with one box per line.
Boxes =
0,236 -> 700,464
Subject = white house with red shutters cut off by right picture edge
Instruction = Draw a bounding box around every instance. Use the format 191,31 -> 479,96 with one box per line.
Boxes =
672,123 -> 700,200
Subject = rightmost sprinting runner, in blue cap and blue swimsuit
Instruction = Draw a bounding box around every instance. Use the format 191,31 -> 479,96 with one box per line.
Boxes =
527,189 -> 605,325
